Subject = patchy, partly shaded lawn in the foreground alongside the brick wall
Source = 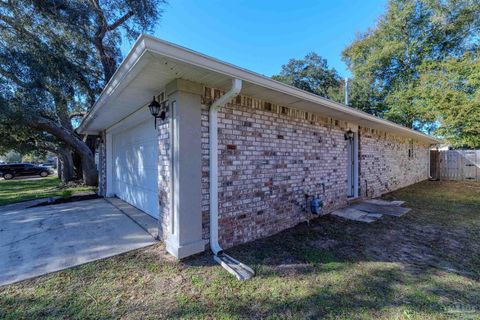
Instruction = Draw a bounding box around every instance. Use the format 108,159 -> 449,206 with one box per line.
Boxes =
0,182 -> 480,319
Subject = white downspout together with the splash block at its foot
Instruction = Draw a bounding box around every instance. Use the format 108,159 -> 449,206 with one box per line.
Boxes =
208,79 -> 255,281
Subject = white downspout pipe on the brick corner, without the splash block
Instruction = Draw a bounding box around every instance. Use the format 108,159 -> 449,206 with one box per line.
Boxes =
208,79 -> 242,255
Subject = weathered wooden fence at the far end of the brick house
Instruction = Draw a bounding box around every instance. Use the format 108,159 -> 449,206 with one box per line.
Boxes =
430,150 -> 480,181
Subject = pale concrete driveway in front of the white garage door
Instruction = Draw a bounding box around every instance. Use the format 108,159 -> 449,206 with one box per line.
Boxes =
0,199 -> 155,285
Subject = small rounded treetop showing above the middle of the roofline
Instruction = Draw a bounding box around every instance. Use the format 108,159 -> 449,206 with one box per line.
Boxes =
272,52 -> 341,98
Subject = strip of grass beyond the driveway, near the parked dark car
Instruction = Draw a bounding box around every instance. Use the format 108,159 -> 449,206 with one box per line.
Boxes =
0,177 -> 93,206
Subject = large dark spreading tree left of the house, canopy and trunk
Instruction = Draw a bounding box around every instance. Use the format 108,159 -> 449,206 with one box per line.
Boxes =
0,0 -> 164,185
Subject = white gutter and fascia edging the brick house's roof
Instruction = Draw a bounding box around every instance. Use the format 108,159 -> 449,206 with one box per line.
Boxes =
77,34 -> 442,144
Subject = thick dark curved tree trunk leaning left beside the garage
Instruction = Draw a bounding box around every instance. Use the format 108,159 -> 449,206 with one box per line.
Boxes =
31,117 -> 98,186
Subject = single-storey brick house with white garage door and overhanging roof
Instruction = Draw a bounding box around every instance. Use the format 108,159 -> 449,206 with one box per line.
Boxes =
78,35 -> 439,258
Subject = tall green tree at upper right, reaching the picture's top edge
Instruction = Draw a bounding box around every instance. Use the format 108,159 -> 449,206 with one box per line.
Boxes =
343,0 -> 480,136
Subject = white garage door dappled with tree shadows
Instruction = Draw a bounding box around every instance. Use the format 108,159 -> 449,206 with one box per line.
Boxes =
112,119 -> 158,219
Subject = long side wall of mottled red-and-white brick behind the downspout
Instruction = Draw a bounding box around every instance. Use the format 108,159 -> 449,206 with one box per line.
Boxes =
202,88 -> 428,248
